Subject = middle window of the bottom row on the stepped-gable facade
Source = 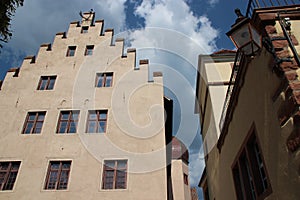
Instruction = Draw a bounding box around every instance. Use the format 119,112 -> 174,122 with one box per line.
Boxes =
45,161 -> 71,190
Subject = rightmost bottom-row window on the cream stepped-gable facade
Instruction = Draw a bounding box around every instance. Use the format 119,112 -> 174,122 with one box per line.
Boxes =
102,160 -> 127,189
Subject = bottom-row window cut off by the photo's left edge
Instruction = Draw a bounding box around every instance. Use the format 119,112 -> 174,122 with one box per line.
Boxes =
0,161 -> 21,190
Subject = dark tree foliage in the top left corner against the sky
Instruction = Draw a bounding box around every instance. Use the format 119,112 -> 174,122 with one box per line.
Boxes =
0,0 -> 24,48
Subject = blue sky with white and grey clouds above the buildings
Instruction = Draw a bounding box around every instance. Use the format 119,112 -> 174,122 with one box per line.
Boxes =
0,0 -> 248,199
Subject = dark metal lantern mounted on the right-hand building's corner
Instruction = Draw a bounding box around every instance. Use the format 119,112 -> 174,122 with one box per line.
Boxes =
226,9 -> 262,56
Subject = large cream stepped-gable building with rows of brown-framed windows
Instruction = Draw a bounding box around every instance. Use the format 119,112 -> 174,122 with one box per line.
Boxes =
0,12 -> 190,200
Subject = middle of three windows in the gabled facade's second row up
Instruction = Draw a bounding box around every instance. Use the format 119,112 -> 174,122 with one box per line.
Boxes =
57,110 -> 79,133
